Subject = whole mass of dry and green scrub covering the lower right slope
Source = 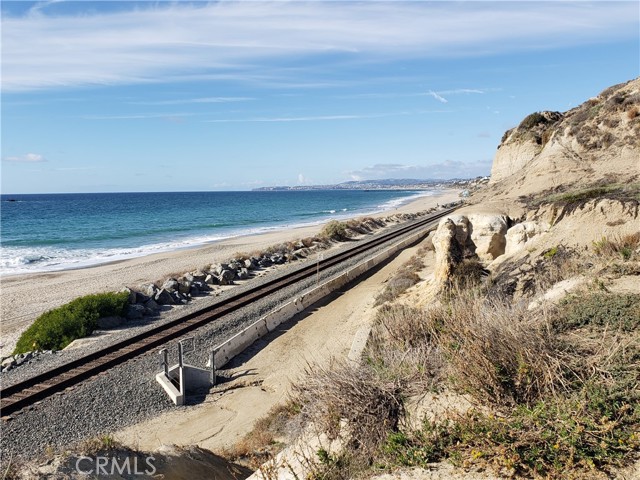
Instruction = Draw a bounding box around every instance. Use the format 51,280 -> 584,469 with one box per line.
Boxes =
296,266 -> 640,479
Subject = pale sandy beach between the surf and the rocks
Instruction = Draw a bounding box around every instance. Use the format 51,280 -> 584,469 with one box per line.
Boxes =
0,190 -> 459,356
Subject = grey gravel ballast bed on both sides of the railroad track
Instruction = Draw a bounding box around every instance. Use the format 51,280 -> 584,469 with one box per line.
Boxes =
0,218 -> 438,464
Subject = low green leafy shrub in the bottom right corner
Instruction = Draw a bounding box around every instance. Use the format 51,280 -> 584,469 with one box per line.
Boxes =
382,378 -> 640,479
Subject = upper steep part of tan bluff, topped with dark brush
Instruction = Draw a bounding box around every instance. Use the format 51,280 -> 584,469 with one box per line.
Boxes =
488,78 -> 640,198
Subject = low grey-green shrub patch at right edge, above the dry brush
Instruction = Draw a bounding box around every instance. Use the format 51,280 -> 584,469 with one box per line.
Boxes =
555,293 -> 640,331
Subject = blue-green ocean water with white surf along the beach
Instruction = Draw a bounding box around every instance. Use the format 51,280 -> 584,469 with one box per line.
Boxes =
0,190 -> 433,276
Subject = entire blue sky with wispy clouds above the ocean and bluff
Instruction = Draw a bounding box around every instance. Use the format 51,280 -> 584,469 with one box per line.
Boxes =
0,0 -> 640,193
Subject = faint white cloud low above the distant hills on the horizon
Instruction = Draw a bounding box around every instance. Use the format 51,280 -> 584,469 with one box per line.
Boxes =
348,160 -> 492,180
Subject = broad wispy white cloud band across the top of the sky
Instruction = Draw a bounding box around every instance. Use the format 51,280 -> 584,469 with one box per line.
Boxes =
2,0 -> 638,91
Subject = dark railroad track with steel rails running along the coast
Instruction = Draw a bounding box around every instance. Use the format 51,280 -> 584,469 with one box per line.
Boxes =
0,209 -> 455,418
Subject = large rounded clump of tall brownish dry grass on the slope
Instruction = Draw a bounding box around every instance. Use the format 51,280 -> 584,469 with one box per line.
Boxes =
431,291 -> 571,406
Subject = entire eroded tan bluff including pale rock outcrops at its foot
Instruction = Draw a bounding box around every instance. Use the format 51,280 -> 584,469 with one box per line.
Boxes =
434,78 -> 640,285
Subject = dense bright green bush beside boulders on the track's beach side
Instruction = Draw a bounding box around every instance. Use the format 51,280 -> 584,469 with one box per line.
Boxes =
13,292 -> 129,355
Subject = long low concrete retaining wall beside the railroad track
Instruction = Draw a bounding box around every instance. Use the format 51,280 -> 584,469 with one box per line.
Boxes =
215,230 -> 429,368
